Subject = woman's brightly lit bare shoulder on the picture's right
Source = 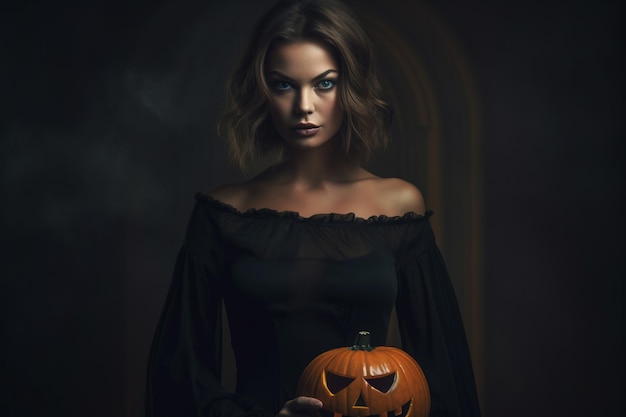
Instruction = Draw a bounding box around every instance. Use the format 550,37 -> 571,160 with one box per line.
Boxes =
370,178 -> 426,215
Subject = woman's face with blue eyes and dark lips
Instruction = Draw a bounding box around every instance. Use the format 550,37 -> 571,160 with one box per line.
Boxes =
265,41 -> 343,150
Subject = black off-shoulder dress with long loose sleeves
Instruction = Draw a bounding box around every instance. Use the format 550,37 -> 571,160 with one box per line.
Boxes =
146,194 -> 479,417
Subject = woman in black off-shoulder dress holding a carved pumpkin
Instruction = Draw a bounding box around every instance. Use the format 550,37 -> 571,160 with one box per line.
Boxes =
147,0 -> 479,417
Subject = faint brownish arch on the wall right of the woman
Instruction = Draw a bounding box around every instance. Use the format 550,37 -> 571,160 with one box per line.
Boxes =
349,0 -> 484,396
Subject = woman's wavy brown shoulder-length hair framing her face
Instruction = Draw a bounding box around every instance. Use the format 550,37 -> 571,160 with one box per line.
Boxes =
218,0 -> 391,170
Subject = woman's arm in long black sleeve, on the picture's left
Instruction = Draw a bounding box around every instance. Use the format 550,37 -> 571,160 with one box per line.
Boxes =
146,201 -> 266,417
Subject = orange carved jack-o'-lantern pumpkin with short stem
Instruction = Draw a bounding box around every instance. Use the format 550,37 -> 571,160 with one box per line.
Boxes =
297,332 -> 430,417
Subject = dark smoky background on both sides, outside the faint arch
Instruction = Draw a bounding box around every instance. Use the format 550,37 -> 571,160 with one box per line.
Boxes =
0,0 -> 626,417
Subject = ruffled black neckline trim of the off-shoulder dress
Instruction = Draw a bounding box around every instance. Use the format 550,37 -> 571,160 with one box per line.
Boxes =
195,192 -> 433,224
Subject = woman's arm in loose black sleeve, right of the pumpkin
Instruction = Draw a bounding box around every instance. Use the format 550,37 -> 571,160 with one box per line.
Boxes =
396,221 -> 480,417
